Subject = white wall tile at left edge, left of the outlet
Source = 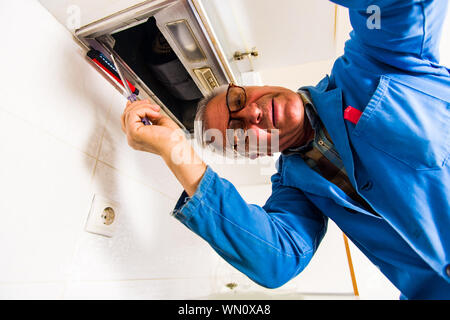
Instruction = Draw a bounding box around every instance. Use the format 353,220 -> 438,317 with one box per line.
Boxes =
0,110 -> 95,282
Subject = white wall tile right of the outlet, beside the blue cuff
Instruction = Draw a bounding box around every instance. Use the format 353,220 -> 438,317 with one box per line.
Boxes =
70,163 -> 218,281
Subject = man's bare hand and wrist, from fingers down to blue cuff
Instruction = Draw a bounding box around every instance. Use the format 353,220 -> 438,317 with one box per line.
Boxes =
121,100 -> 206,196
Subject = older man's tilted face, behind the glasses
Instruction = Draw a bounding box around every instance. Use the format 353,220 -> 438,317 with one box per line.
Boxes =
204,86 -> 304,156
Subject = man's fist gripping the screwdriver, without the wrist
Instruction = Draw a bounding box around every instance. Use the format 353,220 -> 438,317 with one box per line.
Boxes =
121,100 -> 183,155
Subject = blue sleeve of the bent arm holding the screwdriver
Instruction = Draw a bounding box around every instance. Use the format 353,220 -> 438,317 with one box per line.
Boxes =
174,167 -> 327,288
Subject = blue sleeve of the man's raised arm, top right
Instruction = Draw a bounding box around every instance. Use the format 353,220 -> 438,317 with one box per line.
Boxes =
332,0 -> 448,64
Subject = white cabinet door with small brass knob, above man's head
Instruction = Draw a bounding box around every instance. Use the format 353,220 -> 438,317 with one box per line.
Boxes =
197,0 -> 338,85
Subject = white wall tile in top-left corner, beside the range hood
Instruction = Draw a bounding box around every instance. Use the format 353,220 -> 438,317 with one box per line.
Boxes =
0,0 -> 118,156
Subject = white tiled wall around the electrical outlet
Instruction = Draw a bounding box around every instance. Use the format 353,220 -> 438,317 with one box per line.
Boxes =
0,0 -> 358,299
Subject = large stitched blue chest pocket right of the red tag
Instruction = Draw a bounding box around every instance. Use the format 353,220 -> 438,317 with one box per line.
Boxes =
353,76 -> 450,170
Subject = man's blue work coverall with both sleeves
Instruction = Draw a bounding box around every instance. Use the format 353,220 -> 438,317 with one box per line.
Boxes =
174,0 -> 450,299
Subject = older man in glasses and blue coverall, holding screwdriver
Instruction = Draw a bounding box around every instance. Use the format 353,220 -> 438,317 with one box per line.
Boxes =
122,0 -> 450,299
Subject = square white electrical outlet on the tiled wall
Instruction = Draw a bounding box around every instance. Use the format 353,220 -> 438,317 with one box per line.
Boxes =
86,194 -> 119,237
